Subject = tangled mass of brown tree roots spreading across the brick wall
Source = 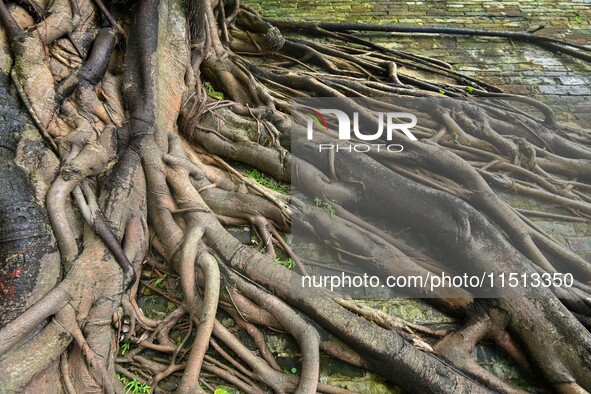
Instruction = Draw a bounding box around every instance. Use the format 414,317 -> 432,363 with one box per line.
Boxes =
0,0 -> 591,393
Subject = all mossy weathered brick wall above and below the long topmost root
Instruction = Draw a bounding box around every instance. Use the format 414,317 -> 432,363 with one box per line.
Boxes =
248,0 -> 591,125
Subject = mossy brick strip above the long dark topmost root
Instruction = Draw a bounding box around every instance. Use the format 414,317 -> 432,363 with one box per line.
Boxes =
249,0 -> 591,35
